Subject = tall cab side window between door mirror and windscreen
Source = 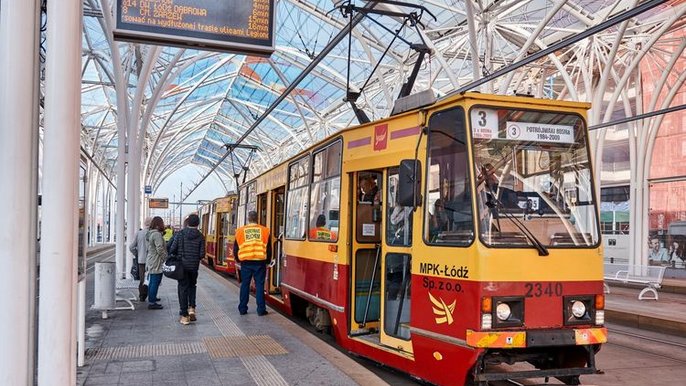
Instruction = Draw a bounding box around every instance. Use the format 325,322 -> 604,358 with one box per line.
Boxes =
424,108 -> 474,245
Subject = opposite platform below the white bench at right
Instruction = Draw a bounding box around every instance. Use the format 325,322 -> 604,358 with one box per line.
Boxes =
605,279 -> 686,337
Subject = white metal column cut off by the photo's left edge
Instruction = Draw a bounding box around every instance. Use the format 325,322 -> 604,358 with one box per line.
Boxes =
0,1 -> 39,385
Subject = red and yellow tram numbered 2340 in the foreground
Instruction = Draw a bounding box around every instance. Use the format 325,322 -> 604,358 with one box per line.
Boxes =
230,93 -> 607,385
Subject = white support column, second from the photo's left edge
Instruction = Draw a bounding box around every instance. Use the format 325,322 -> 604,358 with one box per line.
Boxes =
37,0 -> 83,385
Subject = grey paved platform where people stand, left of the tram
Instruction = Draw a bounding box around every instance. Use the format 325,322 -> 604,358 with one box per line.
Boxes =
77,266 -> 387,386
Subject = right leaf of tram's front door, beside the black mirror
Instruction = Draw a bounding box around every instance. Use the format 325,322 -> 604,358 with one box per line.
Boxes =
380,168 -> 414,353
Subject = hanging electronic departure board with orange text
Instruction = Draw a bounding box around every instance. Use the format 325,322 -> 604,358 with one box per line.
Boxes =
114,0 -> 274,56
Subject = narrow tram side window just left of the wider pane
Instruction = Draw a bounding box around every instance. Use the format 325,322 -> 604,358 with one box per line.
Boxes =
286,157 -> 310,240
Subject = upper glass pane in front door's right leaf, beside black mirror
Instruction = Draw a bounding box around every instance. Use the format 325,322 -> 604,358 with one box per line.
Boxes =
386,168 -> 412,246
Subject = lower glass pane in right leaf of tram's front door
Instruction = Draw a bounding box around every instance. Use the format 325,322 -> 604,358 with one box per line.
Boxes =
384,253 -> 412,339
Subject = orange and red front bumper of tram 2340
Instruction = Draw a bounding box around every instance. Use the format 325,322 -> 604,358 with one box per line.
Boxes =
467,327 -> 607,348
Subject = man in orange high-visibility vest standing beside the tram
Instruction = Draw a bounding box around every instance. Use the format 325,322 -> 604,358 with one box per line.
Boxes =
233,211 -> 272,316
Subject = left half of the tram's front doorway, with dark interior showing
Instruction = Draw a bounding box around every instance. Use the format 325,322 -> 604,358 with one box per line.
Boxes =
350,170 -> 383,335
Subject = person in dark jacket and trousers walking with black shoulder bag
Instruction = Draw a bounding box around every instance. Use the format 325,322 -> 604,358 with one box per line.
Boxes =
170,214 -> 205,325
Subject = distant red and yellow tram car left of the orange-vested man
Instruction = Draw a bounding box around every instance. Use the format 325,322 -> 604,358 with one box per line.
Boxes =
200,198 -> 238,276
